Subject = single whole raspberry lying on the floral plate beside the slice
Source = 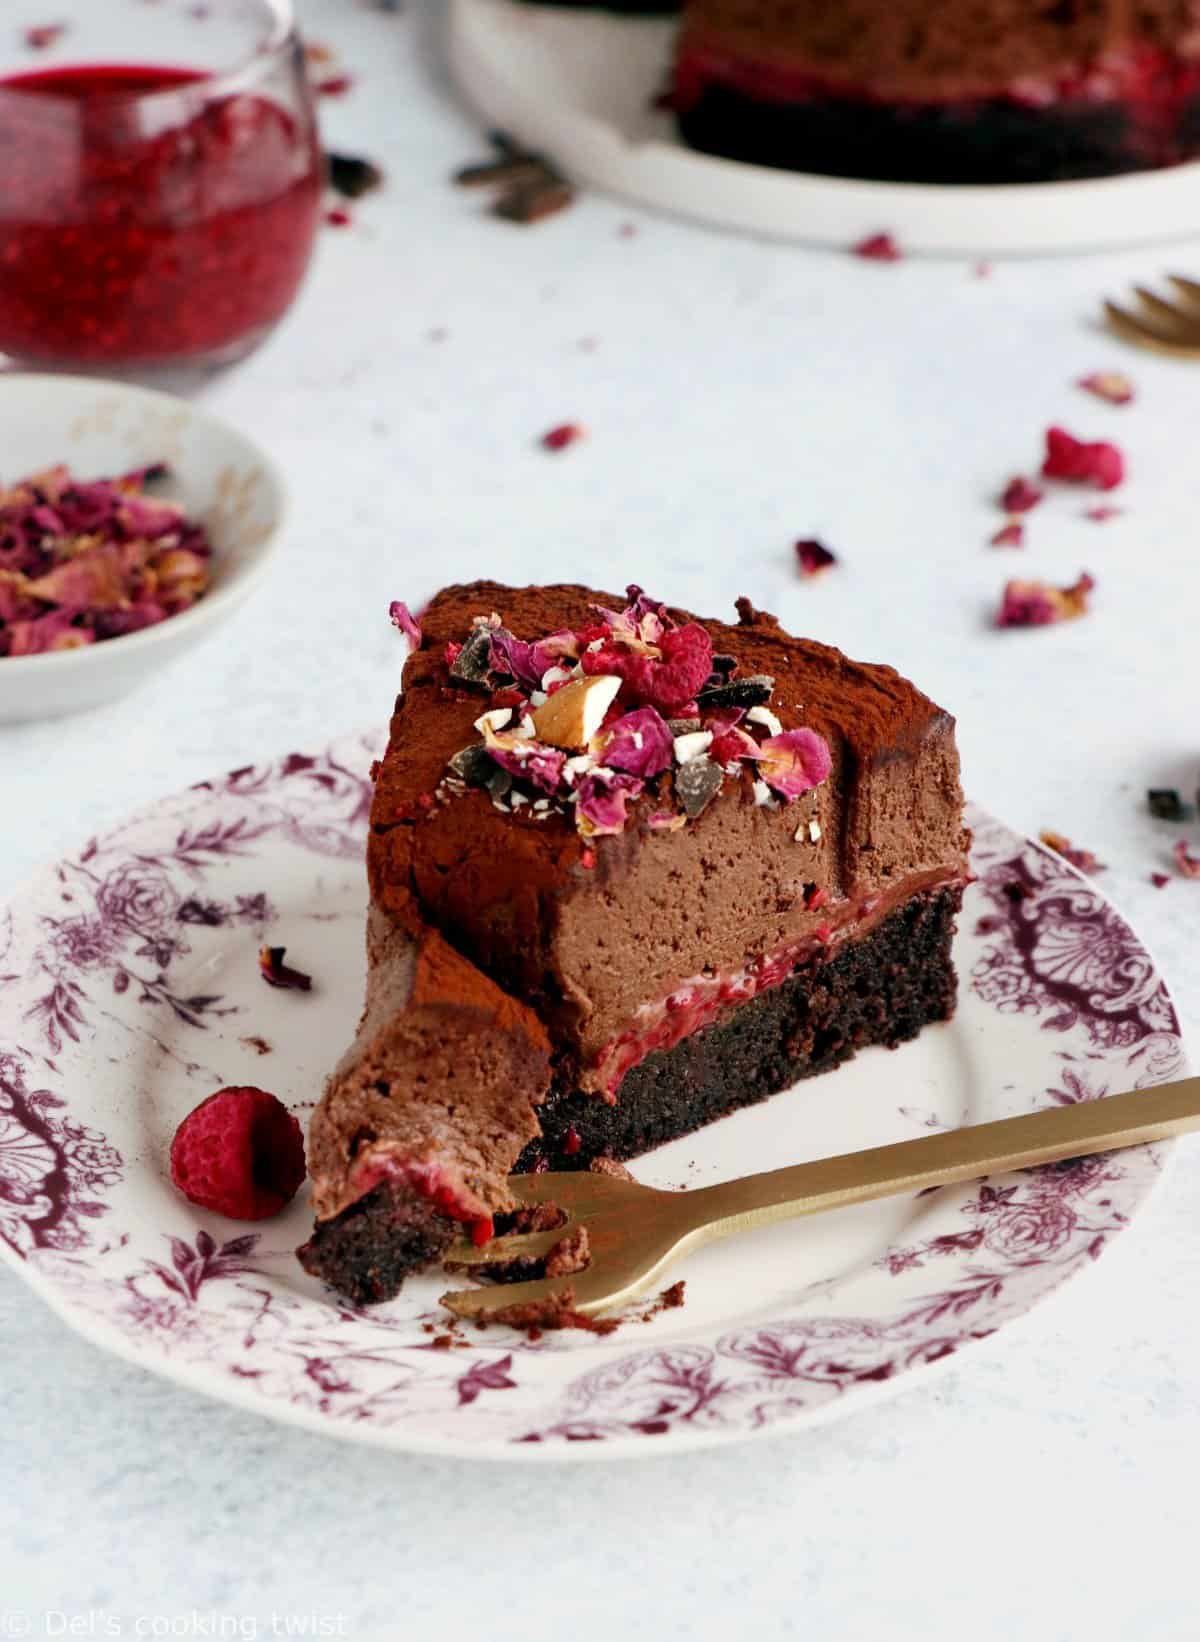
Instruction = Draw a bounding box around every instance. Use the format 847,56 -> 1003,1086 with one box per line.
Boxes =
171,1089 -> 305,1220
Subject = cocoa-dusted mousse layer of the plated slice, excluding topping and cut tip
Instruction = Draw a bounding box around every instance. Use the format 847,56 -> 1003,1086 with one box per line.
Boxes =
368,581 -> 967,1095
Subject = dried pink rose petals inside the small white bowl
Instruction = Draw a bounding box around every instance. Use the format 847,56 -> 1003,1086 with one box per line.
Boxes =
0,466 -> 212,657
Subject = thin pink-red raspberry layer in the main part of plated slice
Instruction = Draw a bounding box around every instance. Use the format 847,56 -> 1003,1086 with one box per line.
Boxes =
588,872 -> 967,1105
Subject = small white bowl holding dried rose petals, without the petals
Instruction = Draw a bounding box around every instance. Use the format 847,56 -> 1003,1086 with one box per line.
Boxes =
0,373 -> 284,724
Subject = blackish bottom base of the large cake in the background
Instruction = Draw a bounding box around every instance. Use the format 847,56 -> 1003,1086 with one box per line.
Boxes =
678,84 -> 1200,184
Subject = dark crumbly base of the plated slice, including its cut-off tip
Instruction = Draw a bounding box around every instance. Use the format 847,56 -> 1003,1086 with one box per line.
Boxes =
299,888 -> 962,1304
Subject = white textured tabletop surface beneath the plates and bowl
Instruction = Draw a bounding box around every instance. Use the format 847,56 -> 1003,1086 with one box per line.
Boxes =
0,0 -> 1200,1642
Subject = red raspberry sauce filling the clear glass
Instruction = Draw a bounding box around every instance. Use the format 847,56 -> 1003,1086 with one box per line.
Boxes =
0,12 -> 323,368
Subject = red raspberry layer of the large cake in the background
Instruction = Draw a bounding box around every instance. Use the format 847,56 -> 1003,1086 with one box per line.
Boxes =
671,38 -> 1200,133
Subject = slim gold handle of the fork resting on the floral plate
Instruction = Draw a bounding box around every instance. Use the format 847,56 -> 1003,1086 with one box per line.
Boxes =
683,1077 -> 1200,1238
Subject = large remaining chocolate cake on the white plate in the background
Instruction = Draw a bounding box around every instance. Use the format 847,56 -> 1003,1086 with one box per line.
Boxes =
675,0 -> 1200,182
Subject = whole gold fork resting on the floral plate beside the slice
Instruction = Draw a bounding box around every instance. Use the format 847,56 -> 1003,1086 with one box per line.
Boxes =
442,1077 -> 1200,1317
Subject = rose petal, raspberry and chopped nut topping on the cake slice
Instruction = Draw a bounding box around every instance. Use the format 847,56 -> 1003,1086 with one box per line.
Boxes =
423,586 -> 832,837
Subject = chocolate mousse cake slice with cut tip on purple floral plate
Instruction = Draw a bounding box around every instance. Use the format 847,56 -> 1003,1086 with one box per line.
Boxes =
300,581 -> 967,1300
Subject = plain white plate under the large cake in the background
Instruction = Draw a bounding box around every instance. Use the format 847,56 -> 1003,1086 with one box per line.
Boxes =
450,0 -> 1200,258
